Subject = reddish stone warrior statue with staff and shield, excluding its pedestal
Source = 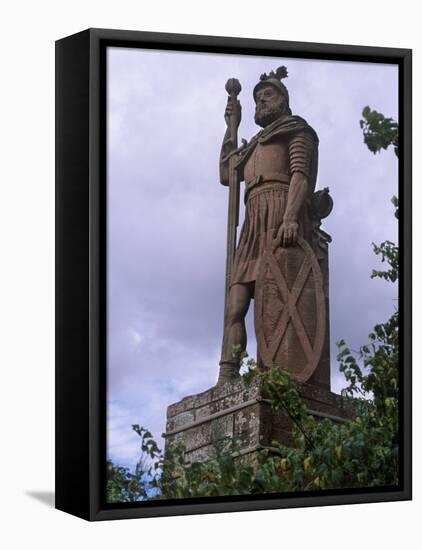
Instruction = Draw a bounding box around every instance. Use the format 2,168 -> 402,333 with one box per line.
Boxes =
218,67 -> 332,389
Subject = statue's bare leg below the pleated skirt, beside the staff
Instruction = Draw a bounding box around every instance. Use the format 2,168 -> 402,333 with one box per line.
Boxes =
217,283 -> 252,384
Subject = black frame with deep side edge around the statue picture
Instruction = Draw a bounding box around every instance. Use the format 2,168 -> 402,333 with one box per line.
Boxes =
56,29 -> 412,521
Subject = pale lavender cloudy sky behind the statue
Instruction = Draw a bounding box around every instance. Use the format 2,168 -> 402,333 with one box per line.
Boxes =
107,48 -> 398,467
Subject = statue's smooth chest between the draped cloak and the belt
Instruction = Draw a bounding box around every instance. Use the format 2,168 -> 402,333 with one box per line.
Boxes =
244,139 -> 289,182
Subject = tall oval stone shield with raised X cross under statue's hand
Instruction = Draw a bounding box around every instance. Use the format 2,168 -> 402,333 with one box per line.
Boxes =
255,237 -> 326,382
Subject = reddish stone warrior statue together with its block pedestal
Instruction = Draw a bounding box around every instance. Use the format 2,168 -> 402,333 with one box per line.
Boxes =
165,67 -> 342,465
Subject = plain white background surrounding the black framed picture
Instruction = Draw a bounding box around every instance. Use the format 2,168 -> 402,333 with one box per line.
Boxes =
0,0 -> 422,550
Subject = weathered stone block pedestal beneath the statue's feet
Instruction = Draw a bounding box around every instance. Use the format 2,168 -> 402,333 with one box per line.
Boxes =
163,380 -> 353,463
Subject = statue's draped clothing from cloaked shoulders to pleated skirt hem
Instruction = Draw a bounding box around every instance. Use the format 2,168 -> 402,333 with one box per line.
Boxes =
230,115 -> 318,292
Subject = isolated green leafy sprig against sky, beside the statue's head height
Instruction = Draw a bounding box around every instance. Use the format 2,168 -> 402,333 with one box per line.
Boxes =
360,106 -> 399,156
